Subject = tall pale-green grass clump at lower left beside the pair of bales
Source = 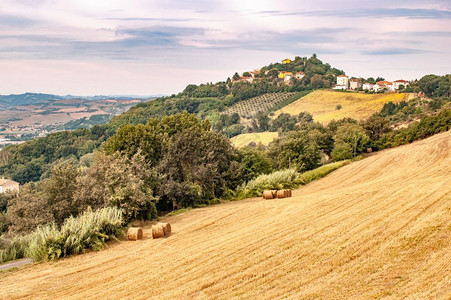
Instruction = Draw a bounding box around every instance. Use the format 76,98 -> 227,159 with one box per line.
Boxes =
0,207 -> 124,262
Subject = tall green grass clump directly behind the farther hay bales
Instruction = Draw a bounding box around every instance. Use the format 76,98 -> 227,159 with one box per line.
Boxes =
237,169 -> 300,198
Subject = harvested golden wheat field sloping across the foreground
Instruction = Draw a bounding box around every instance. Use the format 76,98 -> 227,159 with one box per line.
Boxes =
0,132 -> 451,299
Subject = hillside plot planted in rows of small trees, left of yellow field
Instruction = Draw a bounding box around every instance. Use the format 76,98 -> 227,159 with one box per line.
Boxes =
224,92 -> 296,119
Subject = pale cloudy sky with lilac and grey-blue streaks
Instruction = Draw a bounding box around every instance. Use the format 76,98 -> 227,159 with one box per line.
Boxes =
0,0 -> 451,95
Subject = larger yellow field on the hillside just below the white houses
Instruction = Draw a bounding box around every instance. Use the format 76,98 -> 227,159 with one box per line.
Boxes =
275,90 -> 412,124
